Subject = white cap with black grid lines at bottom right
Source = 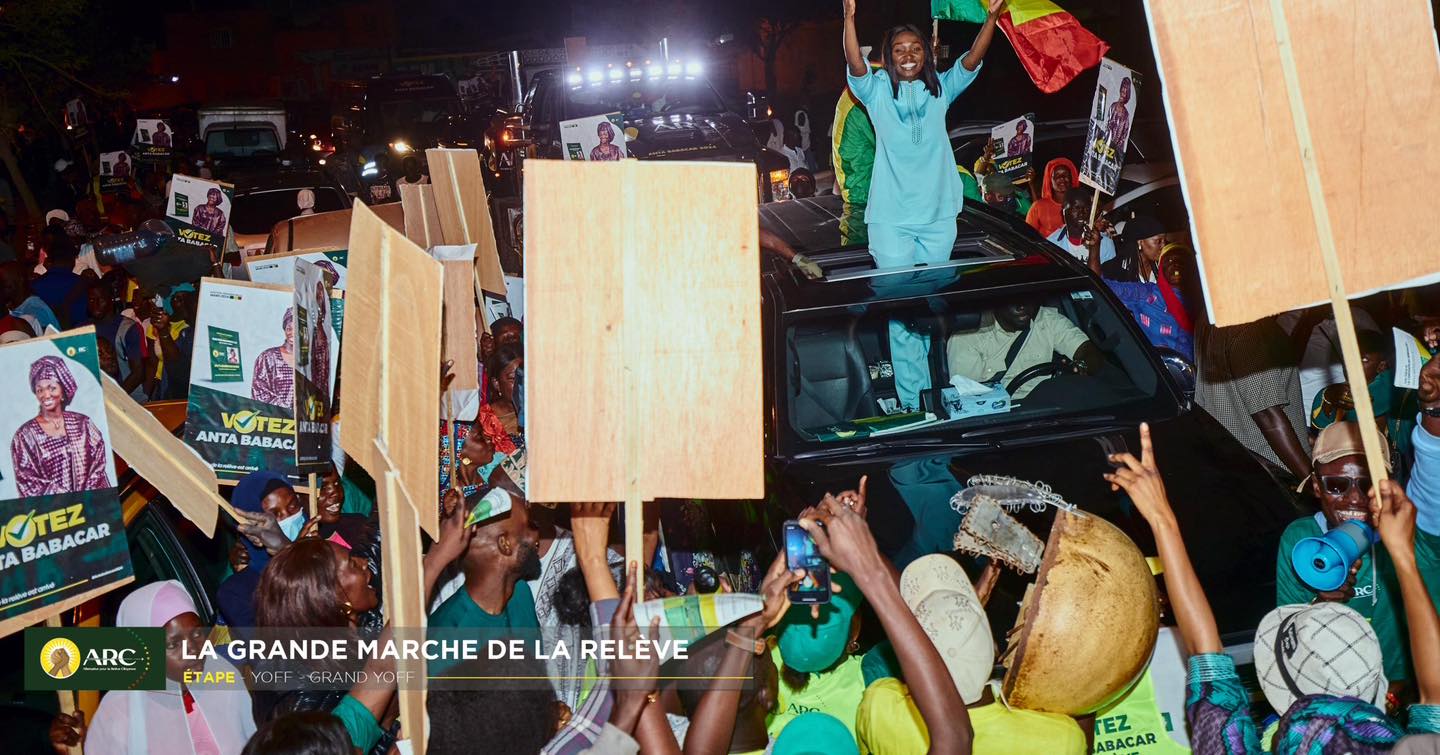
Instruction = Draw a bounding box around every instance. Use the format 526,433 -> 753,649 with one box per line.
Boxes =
1254,602 -> 1390,713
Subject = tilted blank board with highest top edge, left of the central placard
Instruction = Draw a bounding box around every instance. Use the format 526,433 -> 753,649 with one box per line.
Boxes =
425,150 -> 505,297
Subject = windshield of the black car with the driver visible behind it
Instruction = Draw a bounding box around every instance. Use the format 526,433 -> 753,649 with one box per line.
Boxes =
785,280 -> 1168,444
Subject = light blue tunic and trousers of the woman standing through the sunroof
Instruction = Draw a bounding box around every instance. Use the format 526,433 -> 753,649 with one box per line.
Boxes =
845,62 -> 981,409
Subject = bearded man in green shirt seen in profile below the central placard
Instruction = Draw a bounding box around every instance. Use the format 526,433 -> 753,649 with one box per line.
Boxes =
429,491 -> 540,667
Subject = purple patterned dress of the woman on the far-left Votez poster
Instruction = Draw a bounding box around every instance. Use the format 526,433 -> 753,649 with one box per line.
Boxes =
10,412 -> 111,497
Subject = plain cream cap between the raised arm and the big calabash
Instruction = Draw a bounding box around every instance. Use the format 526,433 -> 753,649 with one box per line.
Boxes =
900,553 -> 995,705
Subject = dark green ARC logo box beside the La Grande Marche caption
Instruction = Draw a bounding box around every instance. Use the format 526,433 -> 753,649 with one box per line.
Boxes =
24,627 -> 166,690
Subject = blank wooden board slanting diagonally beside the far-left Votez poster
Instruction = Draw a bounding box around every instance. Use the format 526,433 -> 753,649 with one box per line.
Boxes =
101,375 -> 235,537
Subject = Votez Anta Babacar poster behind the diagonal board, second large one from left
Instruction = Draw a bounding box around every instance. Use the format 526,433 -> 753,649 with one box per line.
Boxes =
184,278 -> 300,480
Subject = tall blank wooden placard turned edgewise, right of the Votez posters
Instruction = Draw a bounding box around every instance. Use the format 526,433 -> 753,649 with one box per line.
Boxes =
340,205 -> 441,537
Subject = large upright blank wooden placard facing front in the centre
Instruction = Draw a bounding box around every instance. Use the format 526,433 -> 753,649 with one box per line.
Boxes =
526,160 -> 765,501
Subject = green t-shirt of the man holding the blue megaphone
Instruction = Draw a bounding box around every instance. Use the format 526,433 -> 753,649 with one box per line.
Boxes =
1274,513 -> 1405,682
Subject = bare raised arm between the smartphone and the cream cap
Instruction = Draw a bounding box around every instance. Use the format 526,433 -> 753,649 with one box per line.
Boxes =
801,494 -> 975,755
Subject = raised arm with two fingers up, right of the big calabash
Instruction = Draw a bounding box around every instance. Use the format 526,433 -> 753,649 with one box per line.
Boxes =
1104,424 -> 1223,654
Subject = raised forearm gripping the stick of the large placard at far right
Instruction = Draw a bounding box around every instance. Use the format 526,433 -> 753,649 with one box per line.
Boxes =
1371,480 -> 1440,705
